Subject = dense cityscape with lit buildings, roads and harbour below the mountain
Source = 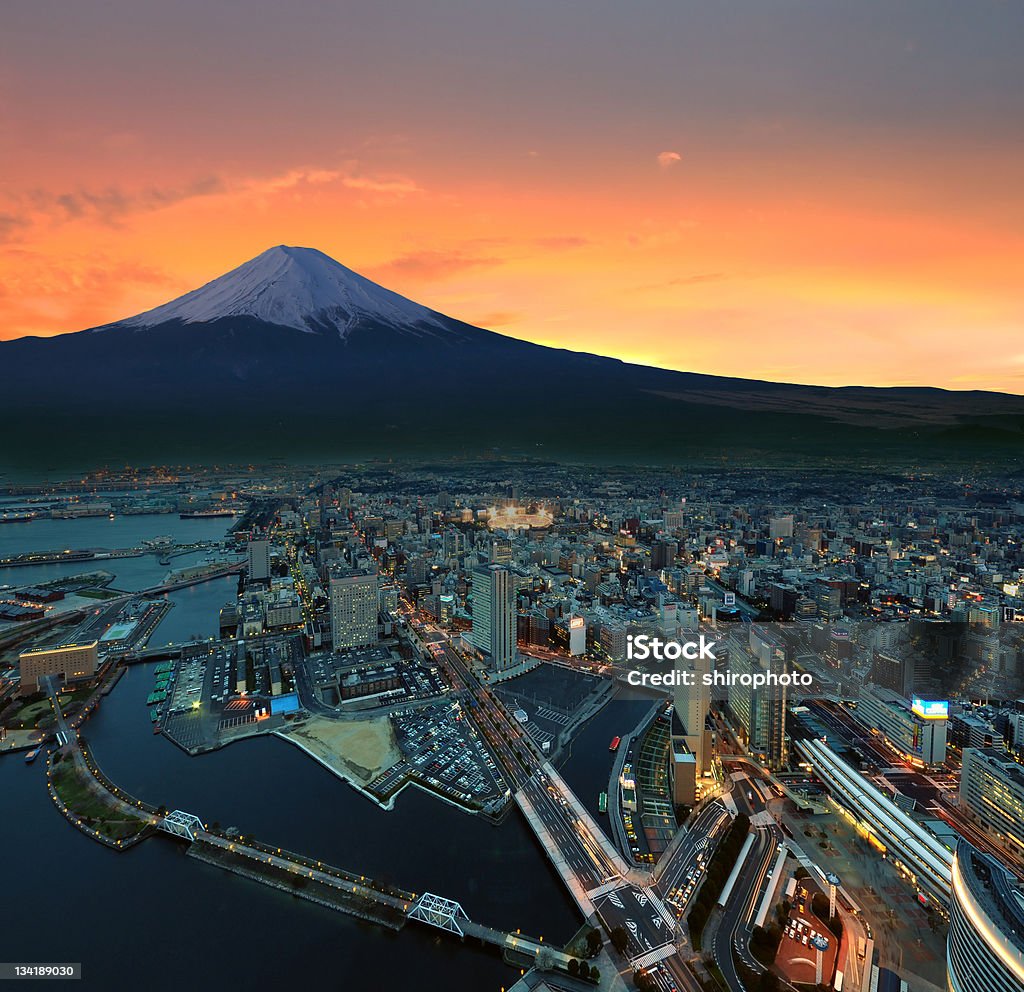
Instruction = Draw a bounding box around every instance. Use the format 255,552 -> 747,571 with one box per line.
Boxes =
0,456 -> 1024,992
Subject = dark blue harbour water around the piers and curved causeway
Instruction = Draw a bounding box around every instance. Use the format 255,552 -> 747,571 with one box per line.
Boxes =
0,517 -> 626,990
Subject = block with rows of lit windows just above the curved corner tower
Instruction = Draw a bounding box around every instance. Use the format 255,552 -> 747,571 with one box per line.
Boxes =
961,747 -> 1024,858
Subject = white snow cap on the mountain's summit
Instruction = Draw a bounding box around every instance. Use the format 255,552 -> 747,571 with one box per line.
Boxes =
120,245 -> 444,337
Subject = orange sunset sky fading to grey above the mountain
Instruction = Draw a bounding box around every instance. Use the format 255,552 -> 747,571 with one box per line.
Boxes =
0,0 -> 1024,393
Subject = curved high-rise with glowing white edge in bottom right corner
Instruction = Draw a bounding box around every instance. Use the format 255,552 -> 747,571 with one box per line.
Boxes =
946,839 -> 1024,992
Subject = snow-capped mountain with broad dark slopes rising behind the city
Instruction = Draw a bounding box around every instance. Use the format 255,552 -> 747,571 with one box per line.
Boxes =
0,247 -> 1024,470
